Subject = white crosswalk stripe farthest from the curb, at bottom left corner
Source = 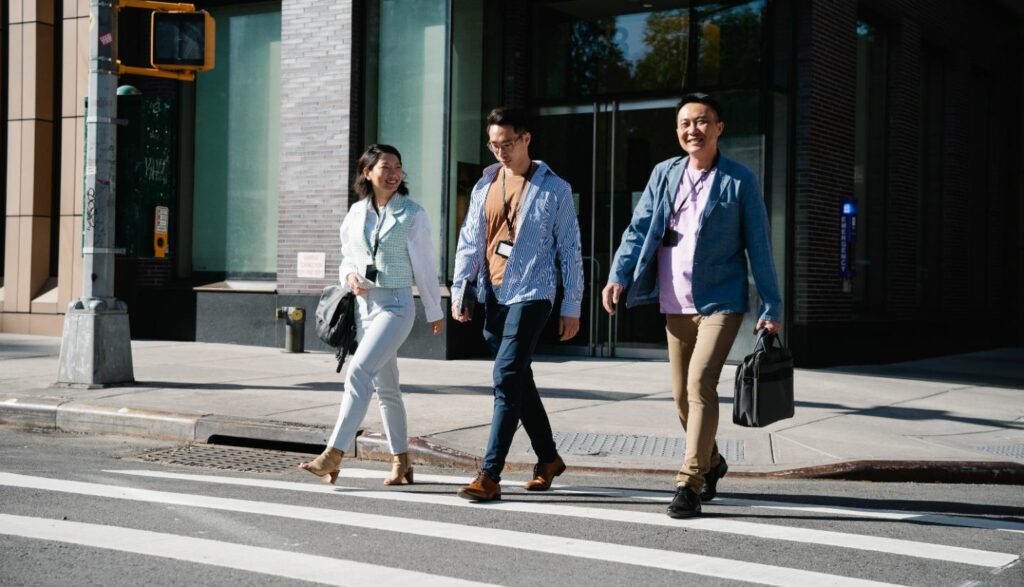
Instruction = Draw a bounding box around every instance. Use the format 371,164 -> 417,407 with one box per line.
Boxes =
0,513 -> 491,587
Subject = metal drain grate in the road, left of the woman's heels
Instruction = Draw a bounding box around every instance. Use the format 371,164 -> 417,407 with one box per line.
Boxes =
126,445 -> 310,473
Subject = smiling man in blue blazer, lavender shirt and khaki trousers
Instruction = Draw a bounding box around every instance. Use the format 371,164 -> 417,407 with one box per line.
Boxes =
602,93 -> 782,517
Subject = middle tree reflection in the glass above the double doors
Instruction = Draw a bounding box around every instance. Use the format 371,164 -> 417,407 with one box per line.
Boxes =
636,9 -> 689,89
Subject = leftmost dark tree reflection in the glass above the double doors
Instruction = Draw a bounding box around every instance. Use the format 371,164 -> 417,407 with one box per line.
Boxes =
569,18 -> 632,95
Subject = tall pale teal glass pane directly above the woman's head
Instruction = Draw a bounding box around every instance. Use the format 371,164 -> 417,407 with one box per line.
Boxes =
359,0 -> 447,272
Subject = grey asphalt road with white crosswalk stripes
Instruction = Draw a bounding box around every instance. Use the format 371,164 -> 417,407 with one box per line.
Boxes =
0,428 -> 1024,587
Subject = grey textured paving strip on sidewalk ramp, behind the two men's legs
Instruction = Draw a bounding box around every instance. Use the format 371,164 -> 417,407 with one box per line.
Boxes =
536,432 -> 743,462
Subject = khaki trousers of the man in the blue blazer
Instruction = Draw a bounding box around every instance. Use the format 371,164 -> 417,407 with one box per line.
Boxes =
665,313 -> 743,493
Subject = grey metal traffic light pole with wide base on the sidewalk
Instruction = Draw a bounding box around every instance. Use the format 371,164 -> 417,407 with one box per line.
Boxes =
57,0 -> 134,387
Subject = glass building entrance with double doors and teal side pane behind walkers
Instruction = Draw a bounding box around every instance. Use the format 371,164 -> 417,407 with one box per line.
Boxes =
364,0 -> 794,358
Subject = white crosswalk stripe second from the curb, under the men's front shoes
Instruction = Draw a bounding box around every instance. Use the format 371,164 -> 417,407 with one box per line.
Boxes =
109,470 -> 1018,568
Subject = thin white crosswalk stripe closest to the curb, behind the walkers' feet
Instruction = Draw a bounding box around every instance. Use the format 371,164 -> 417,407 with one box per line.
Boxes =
340,468 -> 1024,534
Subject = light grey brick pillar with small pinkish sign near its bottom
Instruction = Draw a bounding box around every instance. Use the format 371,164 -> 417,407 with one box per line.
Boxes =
278,0 -> 357,293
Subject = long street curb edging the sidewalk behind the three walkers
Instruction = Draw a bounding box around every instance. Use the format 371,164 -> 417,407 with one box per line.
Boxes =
0,397 -> 1024,486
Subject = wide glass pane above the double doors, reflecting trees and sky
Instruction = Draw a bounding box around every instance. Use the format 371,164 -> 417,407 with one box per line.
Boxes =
532,0 -> 767,101
